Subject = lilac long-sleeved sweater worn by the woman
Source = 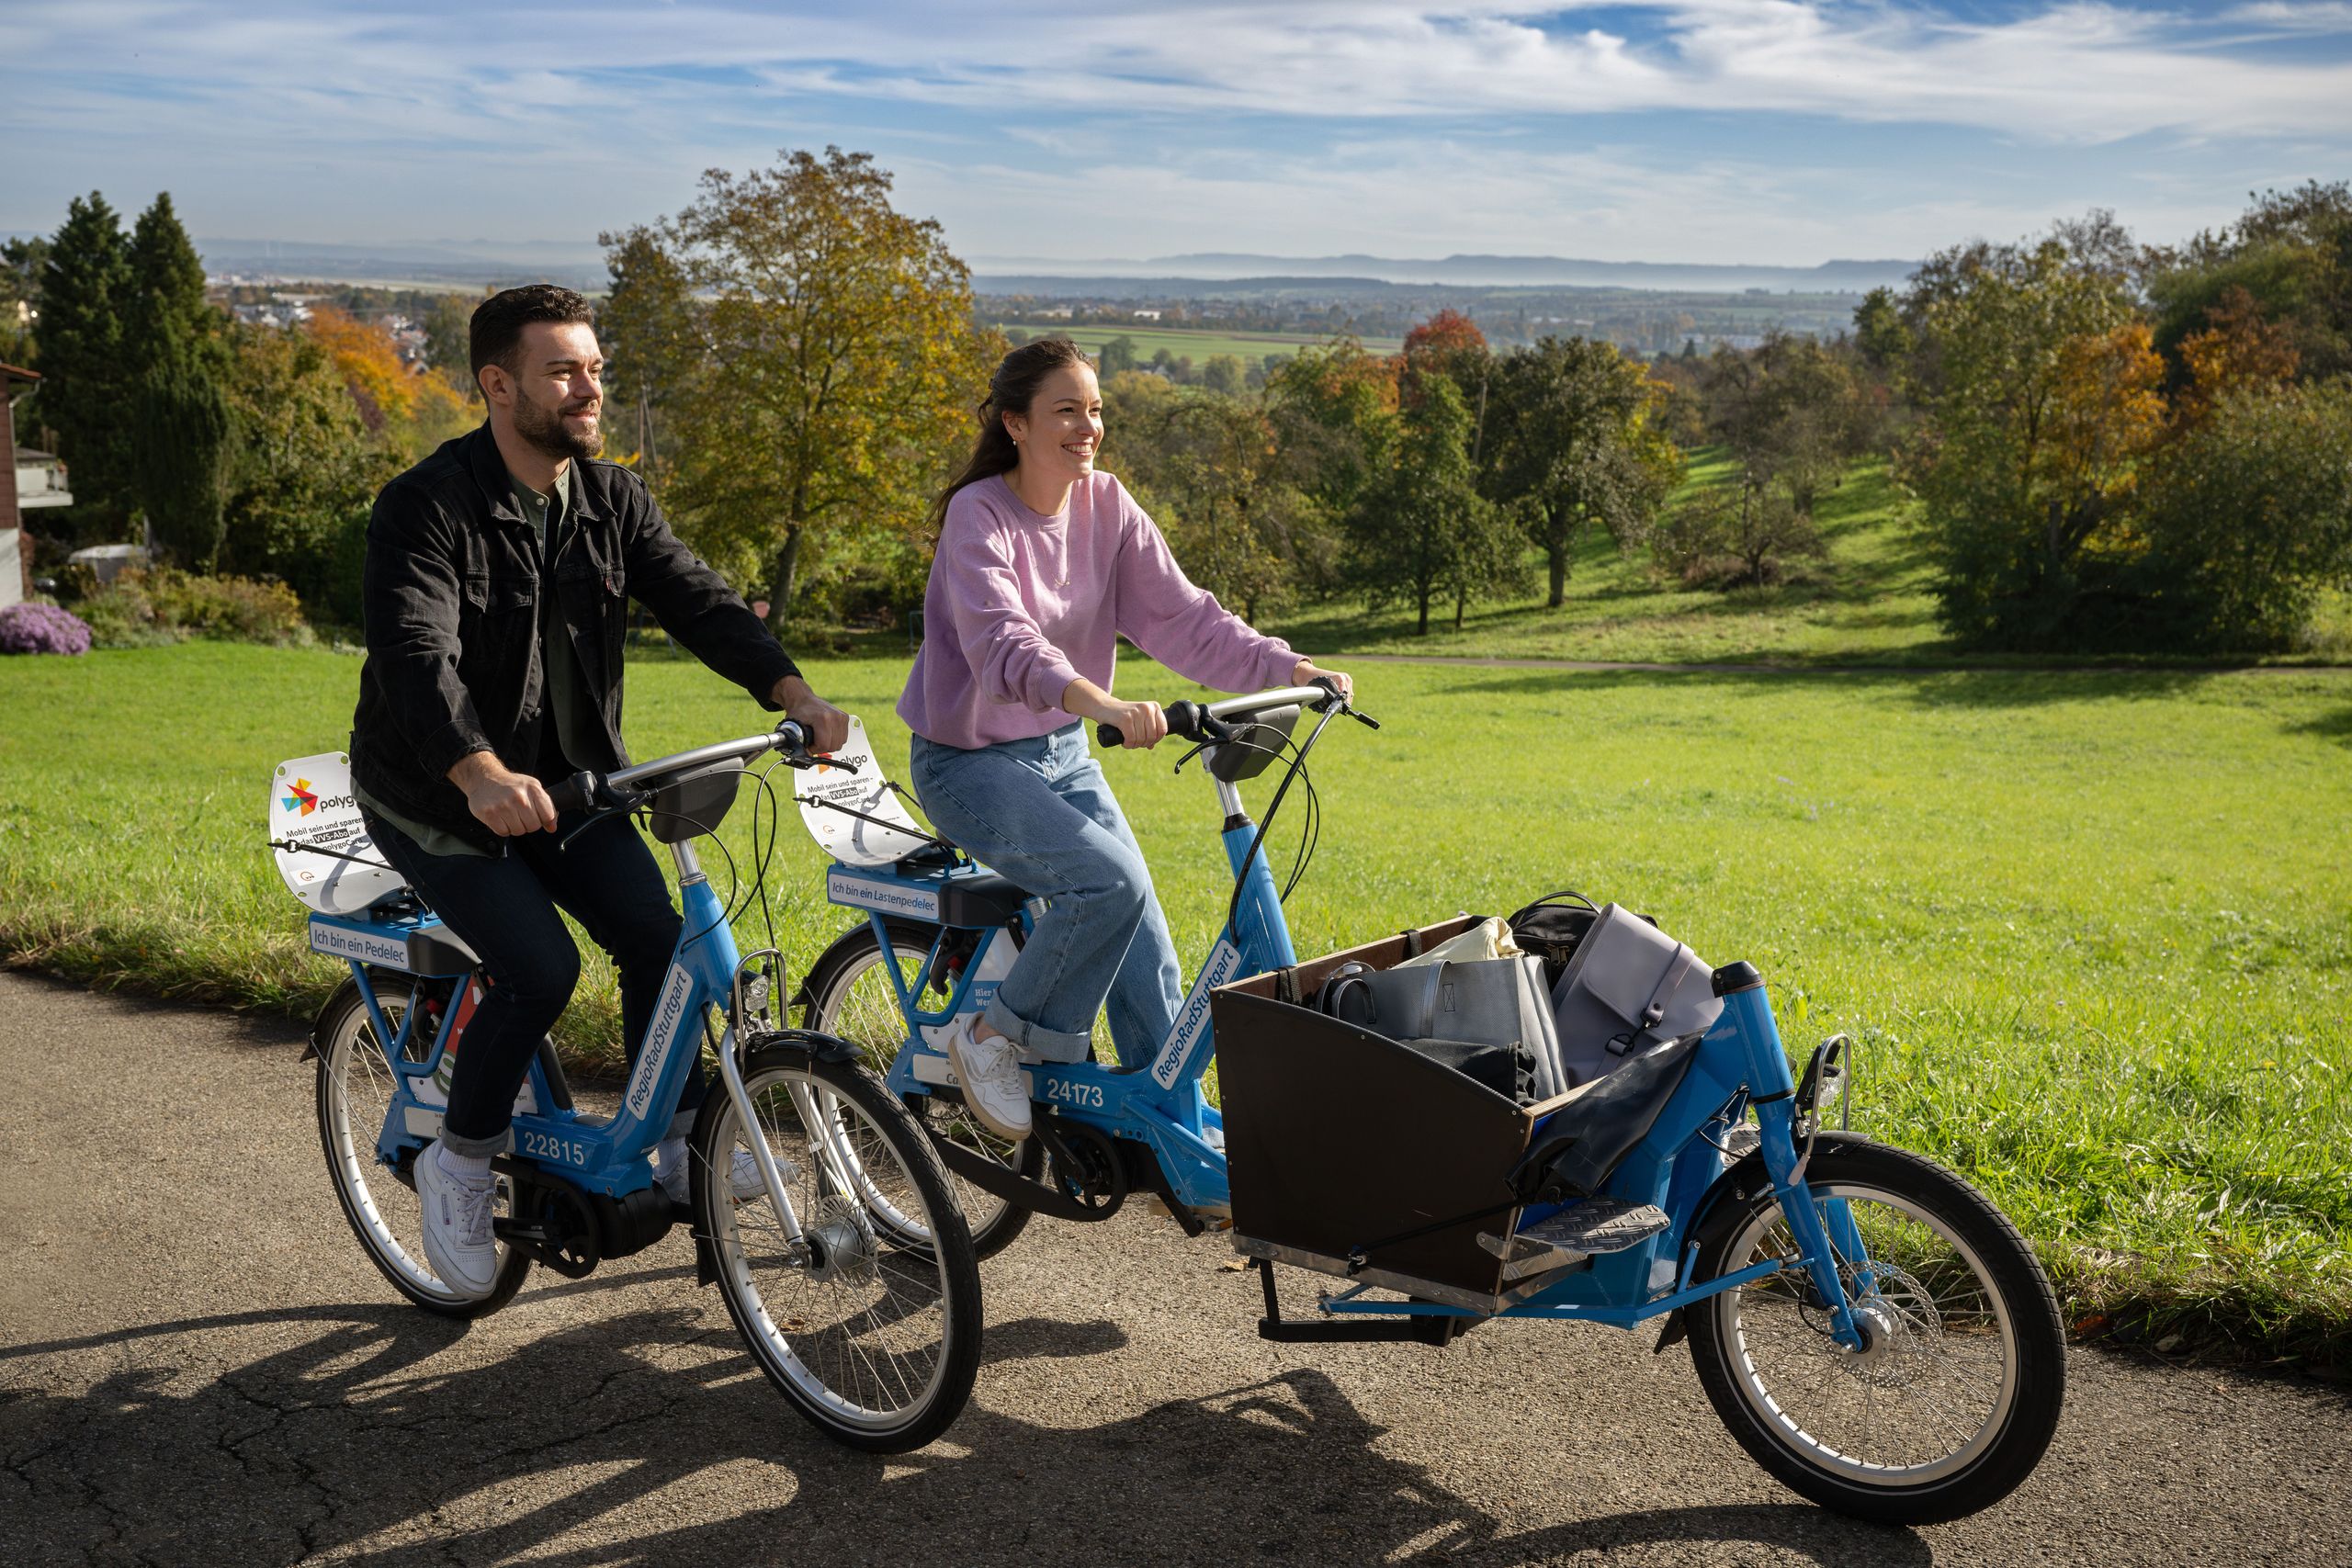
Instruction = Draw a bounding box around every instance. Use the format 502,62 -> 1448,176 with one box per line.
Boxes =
899,472 -> 1298,750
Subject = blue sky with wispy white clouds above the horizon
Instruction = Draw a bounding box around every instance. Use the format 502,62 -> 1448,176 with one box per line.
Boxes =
0,0 -> 2352,265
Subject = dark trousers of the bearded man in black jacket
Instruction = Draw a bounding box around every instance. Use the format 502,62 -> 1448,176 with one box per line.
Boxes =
367,813 -> 706,1155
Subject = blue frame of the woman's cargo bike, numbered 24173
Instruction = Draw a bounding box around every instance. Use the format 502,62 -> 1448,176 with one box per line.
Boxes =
826,700 -> 1865,1347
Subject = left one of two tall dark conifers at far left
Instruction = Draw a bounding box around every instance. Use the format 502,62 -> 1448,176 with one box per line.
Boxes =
35,190 -> 131,538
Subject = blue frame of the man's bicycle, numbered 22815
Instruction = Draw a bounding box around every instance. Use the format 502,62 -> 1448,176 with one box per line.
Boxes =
311,844 -> 818,1244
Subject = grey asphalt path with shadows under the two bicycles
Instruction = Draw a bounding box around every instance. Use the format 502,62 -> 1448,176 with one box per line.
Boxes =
0,974 -> 2352,1568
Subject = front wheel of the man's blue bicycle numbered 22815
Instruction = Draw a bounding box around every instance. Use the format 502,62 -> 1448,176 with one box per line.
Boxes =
694,1046 -> 981,1453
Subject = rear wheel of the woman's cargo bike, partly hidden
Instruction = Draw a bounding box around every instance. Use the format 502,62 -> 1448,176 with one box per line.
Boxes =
802,919 -> 1045,1258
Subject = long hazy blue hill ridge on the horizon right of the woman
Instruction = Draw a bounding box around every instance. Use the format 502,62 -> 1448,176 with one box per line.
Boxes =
974,252 -> 1919,294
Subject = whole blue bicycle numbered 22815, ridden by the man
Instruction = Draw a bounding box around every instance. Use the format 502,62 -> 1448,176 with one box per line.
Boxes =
291,722 -> 981,1453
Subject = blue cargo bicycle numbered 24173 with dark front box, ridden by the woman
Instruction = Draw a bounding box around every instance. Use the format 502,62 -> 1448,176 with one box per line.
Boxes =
797,686 -> 2065,1523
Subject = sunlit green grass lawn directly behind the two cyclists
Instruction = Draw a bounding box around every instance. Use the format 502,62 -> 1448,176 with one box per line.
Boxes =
0,644 -> 2352,1361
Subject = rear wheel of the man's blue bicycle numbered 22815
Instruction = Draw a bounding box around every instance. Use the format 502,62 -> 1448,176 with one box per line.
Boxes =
312,974 -> 532,1319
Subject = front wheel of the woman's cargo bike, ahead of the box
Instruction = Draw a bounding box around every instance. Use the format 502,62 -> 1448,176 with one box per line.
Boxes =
1689,1140 -> 2065,1526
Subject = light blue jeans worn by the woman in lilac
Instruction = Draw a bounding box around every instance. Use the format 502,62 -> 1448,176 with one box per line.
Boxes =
910,724 -> 1183,1067
